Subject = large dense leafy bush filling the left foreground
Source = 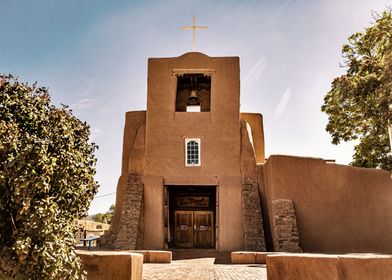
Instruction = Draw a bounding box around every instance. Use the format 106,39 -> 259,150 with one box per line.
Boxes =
0,75 -> 98,279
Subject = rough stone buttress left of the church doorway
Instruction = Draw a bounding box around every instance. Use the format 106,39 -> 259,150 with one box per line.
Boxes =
108,174 -> 143,250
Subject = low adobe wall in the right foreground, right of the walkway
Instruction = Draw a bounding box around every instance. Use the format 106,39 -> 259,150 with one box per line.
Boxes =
267,254 -> 392,280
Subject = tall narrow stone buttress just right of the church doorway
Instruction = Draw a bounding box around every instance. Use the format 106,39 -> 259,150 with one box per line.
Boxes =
242,177 -> 265,251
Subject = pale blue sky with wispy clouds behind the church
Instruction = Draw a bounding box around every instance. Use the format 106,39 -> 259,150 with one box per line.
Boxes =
0,0 -> 392,213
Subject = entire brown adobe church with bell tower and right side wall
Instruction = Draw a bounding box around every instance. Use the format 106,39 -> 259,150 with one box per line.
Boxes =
102,52 -> 392,253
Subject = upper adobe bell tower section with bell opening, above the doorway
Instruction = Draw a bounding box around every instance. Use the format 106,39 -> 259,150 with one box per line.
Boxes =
144,52 -> 240,178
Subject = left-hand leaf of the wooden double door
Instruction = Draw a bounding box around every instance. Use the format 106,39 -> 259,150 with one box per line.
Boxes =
175,211 -> 193,248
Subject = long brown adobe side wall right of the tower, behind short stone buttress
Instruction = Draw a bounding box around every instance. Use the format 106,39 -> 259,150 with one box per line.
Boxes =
264,156 -> 392,253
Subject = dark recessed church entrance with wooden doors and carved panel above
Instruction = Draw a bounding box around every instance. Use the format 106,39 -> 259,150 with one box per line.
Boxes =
168,186 -> 216,249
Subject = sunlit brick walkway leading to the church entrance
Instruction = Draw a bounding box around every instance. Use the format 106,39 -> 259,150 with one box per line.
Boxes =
143,258 -> 267,280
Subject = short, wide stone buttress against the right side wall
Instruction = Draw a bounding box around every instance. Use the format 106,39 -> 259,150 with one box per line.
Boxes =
272,199 -> 302,253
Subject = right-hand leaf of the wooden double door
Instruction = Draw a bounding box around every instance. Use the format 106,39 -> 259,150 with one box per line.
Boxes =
193,211 -> 214,248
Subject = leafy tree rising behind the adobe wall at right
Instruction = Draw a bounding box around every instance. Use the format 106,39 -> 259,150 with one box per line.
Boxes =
321,8 -> 392,172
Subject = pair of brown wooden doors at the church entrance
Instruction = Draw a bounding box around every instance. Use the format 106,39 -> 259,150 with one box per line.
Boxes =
174,210 -> 214,248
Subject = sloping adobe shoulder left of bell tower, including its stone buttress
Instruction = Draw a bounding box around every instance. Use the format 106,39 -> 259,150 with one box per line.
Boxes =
101,111 -> 146,249
